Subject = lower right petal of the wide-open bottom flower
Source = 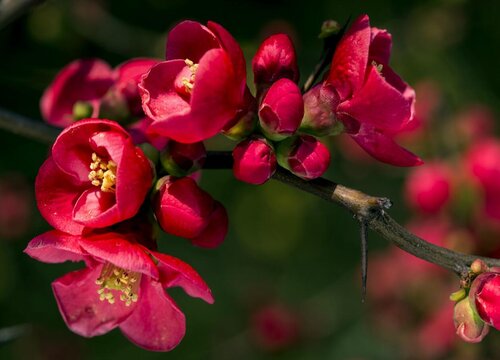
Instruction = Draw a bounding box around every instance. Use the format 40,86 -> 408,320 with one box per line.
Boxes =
120,280 -> 186,351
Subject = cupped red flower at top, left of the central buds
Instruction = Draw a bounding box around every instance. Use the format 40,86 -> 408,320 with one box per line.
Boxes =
139,21 -> 248,143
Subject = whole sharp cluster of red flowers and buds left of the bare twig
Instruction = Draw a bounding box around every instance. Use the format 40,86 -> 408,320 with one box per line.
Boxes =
26,15 -> 421,351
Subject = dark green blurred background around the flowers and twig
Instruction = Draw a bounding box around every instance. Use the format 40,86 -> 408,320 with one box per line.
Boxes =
0,0 -> 500,360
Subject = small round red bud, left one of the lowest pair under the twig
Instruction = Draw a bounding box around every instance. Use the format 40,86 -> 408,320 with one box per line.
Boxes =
233,139 -> 276,185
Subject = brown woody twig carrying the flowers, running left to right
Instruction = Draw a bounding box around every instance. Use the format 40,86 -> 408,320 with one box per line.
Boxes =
0,109 -> 500,276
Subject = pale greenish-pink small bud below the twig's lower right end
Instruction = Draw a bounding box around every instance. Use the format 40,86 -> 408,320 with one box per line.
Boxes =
453,297 -> 489,343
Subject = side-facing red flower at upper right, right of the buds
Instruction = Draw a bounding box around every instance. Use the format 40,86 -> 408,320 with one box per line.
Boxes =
323,15 -> 422,166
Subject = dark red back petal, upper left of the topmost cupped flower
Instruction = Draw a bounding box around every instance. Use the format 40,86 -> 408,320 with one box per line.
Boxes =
166,20 -> 220,63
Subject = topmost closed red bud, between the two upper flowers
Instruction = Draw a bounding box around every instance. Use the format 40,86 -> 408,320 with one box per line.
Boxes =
252,34 -> 299,86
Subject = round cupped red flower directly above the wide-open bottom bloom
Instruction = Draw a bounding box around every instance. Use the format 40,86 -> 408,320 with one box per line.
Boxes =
35,119 -> 153,235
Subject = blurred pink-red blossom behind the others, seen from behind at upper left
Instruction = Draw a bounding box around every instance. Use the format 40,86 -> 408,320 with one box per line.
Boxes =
40,58 -> 158,127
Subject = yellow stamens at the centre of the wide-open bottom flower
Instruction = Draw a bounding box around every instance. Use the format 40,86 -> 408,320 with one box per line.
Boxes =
95,263 -> 141,306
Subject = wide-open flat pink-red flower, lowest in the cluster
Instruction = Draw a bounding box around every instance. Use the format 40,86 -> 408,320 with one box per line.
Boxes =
25,226 -> 214,351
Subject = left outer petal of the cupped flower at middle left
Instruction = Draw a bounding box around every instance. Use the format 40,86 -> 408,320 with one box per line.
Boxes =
35,157 -> 84,235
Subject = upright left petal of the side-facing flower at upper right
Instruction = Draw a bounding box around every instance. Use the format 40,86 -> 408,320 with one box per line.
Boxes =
327,15 -> 371,101
